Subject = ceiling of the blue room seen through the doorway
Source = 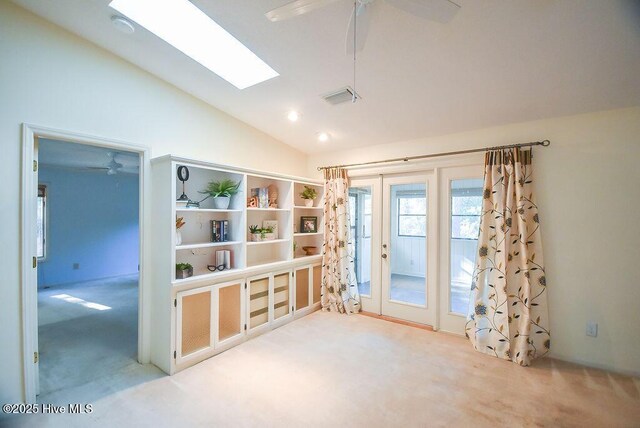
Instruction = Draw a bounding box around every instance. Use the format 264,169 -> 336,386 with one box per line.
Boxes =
38,138 -> 140,174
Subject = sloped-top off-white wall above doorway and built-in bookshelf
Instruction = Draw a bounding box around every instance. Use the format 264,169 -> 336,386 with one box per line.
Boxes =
0,1 -> 306,403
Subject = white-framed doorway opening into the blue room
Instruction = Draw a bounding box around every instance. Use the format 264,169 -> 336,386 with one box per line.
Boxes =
21,124 -> 158,404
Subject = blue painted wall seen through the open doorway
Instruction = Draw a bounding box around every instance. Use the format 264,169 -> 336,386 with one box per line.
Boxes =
38,165 -> 139,287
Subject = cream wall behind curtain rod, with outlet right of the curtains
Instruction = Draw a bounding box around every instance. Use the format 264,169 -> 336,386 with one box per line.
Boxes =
309,107 -> 640,374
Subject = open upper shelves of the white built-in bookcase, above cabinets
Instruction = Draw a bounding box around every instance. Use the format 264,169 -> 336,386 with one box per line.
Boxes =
165,161 -> 323,285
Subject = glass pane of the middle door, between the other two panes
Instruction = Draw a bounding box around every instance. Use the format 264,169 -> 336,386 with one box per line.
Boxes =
389,183 -> 427,306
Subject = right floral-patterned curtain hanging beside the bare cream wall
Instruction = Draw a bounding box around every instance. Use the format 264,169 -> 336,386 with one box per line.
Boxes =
465,148 -> 550,366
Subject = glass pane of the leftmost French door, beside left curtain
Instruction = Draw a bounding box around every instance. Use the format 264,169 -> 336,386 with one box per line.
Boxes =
349,186 -> 372,297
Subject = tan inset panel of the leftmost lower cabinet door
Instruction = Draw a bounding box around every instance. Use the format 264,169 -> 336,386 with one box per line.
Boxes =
181,291 -> 211,356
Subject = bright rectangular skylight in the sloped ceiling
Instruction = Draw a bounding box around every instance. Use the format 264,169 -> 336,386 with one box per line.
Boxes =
109,0 -> 278,89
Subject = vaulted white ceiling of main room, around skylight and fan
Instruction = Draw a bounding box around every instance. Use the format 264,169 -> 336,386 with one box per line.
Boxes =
14,0 -> 640,153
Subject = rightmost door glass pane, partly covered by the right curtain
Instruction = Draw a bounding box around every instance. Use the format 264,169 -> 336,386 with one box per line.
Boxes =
449,179 -> 483,314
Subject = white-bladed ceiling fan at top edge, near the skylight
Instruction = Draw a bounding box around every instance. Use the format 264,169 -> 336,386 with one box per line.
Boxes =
265,0 -> 460,55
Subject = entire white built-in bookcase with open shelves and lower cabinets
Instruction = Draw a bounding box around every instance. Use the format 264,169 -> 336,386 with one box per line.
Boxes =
150,155 -> 323,374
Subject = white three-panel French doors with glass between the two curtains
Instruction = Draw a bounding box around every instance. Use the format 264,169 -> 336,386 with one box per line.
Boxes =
349,166 -> 482,334
